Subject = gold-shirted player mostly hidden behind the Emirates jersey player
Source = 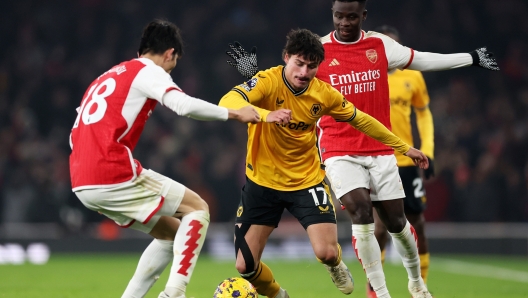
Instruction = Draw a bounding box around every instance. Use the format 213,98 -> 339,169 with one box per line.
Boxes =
367,25 -> 434,298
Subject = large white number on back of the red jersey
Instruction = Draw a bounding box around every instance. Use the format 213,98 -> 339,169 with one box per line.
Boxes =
73,78 -> 116,128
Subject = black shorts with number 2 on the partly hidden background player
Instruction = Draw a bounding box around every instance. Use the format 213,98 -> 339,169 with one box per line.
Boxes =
399,166 -> 427,214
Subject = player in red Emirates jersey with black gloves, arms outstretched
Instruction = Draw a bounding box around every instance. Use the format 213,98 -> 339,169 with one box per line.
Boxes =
228,0 -> 499,298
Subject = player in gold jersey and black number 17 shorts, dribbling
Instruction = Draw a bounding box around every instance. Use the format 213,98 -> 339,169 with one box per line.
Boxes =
219,29 -> 428,298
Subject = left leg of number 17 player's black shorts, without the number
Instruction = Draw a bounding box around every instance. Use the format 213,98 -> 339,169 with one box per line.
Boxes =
236,178 -> 284,227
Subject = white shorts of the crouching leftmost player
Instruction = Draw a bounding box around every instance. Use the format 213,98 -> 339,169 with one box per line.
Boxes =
75,169 -> 186,233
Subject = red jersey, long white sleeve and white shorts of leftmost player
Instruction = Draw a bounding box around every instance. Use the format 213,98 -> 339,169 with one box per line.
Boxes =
70,58 -> 228,229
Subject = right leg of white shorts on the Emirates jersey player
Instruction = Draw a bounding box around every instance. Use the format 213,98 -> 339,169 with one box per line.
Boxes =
369,155 -> 405,201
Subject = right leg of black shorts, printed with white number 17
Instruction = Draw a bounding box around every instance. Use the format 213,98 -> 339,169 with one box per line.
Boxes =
286,181 -> 336,229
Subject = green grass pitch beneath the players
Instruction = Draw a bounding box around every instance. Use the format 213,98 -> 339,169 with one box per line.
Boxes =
0,254 -> 528,298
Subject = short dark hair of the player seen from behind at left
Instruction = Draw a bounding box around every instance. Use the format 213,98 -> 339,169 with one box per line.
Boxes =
138,20 -> 183,57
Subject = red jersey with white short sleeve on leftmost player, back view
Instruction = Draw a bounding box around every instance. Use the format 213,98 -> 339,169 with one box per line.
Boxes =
70,58 -> 183,191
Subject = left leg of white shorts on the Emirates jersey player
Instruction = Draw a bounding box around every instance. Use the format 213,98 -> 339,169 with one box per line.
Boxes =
325,156 -> 371,199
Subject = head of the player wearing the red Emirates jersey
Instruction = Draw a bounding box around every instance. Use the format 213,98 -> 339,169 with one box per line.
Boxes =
332,1 -> 367,42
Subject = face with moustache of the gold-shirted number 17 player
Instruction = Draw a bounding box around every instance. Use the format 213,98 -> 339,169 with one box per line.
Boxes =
284,55 -> 319,90
